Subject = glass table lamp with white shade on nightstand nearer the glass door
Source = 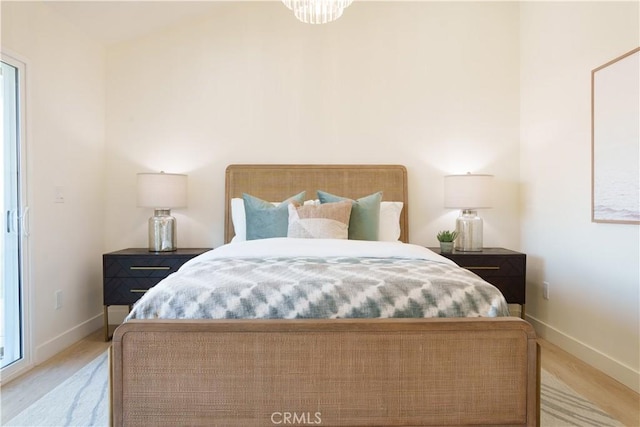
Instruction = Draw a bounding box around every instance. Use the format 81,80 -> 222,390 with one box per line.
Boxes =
138,172 -> 187,252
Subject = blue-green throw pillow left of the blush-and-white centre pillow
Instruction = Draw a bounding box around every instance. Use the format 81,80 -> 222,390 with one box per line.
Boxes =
242,191 -> 305,240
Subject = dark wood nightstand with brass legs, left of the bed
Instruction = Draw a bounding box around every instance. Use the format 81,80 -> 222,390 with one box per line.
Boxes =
102,248 -> 211,341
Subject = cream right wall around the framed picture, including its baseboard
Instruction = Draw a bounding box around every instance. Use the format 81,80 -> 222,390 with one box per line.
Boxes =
520,2 -> 640,391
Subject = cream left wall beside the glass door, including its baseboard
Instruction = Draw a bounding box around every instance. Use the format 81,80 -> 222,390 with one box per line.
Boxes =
2,2 -> 105,372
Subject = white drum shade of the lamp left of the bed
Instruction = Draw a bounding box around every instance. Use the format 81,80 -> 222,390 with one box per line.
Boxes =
138,172 -> 187,209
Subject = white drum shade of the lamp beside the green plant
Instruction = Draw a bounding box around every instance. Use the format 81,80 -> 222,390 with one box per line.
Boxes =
444,173 -> 493,209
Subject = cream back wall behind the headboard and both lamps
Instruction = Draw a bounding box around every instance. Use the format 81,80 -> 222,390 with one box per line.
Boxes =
105,2 -> 519,250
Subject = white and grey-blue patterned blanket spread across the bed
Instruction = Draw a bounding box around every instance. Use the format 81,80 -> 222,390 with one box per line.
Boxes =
127,256 -> 509,319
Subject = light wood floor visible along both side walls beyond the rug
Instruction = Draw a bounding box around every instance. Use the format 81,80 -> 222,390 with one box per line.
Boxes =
1,330 -> 640,427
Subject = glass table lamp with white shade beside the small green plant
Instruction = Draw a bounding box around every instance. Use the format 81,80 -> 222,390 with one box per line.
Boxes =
444,173 -> 493,252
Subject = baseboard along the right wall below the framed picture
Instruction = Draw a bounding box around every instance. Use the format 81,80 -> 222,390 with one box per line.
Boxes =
526,314 -> 640,393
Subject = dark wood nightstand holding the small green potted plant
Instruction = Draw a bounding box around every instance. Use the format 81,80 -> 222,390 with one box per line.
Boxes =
429,248 -> 527,319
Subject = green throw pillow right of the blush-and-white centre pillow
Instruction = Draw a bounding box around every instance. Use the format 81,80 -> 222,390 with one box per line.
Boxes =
318,190 -> 382,241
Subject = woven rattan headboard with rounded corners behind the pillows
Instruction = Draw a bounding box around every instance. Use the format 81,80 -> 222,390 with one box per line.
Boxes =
224,165 -> 409,243
